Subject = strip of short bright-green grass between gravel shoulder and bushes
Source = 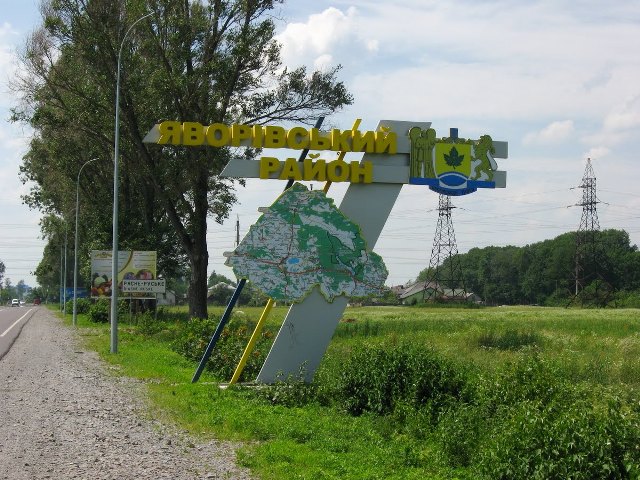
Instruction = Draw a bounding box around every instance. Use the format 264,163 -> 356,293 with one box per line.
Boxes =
61,308 -> 460,480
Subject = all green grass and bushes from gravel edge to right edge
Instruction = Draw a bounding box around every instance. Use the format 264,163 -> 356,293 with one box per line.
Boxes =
61,307 -> 640,479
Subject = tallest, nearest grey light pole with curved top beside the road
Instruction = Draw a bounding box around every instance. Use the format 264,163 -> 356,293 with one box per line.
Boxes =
111,13 -> 152,353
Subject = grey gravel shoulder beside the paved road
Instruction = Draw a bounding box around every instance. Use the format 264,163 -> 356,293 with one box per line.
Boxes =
0,308 -> 251,480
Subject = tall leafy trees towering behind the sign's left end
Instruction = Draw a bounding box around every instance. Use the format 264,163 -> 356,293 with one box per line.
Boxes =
14,0 -> 352,317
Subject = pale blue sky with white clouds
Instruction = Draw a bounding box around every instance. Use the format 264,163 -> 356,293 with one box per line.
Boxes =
0,0 -> 640,286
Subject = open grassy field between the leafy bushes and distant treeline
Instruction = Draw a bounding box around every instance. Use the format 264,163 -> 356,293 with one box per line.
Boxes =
330,307 -> 640,386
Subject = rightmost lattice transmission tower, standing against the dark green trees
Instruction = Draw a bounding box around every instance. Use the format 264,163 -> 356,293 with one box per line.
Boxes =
572,158 -> 612,306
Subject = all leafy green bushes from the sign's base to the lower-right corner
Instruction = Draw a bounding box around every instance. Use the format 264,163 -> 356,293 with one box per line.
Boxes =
173,319 -> 640,480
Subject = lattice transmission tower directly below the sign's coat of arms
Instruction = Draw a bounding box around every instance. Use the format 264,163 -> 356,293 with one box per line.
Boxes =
423,194 -> 467,301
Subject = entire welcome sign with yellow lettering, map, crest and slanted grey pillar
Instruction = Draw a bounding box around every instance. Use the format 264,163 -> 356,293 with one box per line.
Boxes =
144,120 -> 508,383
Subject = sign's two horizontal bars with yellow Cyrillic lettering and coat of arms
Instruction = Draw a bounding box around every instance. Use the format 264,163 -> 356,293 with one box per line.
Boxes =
144,121 -> 507,195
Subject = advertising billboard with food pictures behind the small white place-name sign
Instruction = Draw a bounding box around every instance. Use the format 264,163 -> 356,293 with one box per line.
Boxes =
91,250 -> 157,299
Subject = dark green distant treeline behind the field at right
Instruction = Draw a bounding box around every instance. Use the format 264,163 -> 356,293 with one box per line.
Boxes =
418,229 -> 640,306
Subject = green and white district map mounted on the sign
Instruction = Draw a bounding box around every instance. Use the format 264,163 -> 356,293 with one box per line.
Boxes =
225,183 -> 388,302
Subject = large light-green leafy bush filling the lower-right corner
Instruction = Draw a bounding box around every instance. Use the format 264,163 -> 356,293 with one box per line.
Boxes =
435,356 -> 640,479
